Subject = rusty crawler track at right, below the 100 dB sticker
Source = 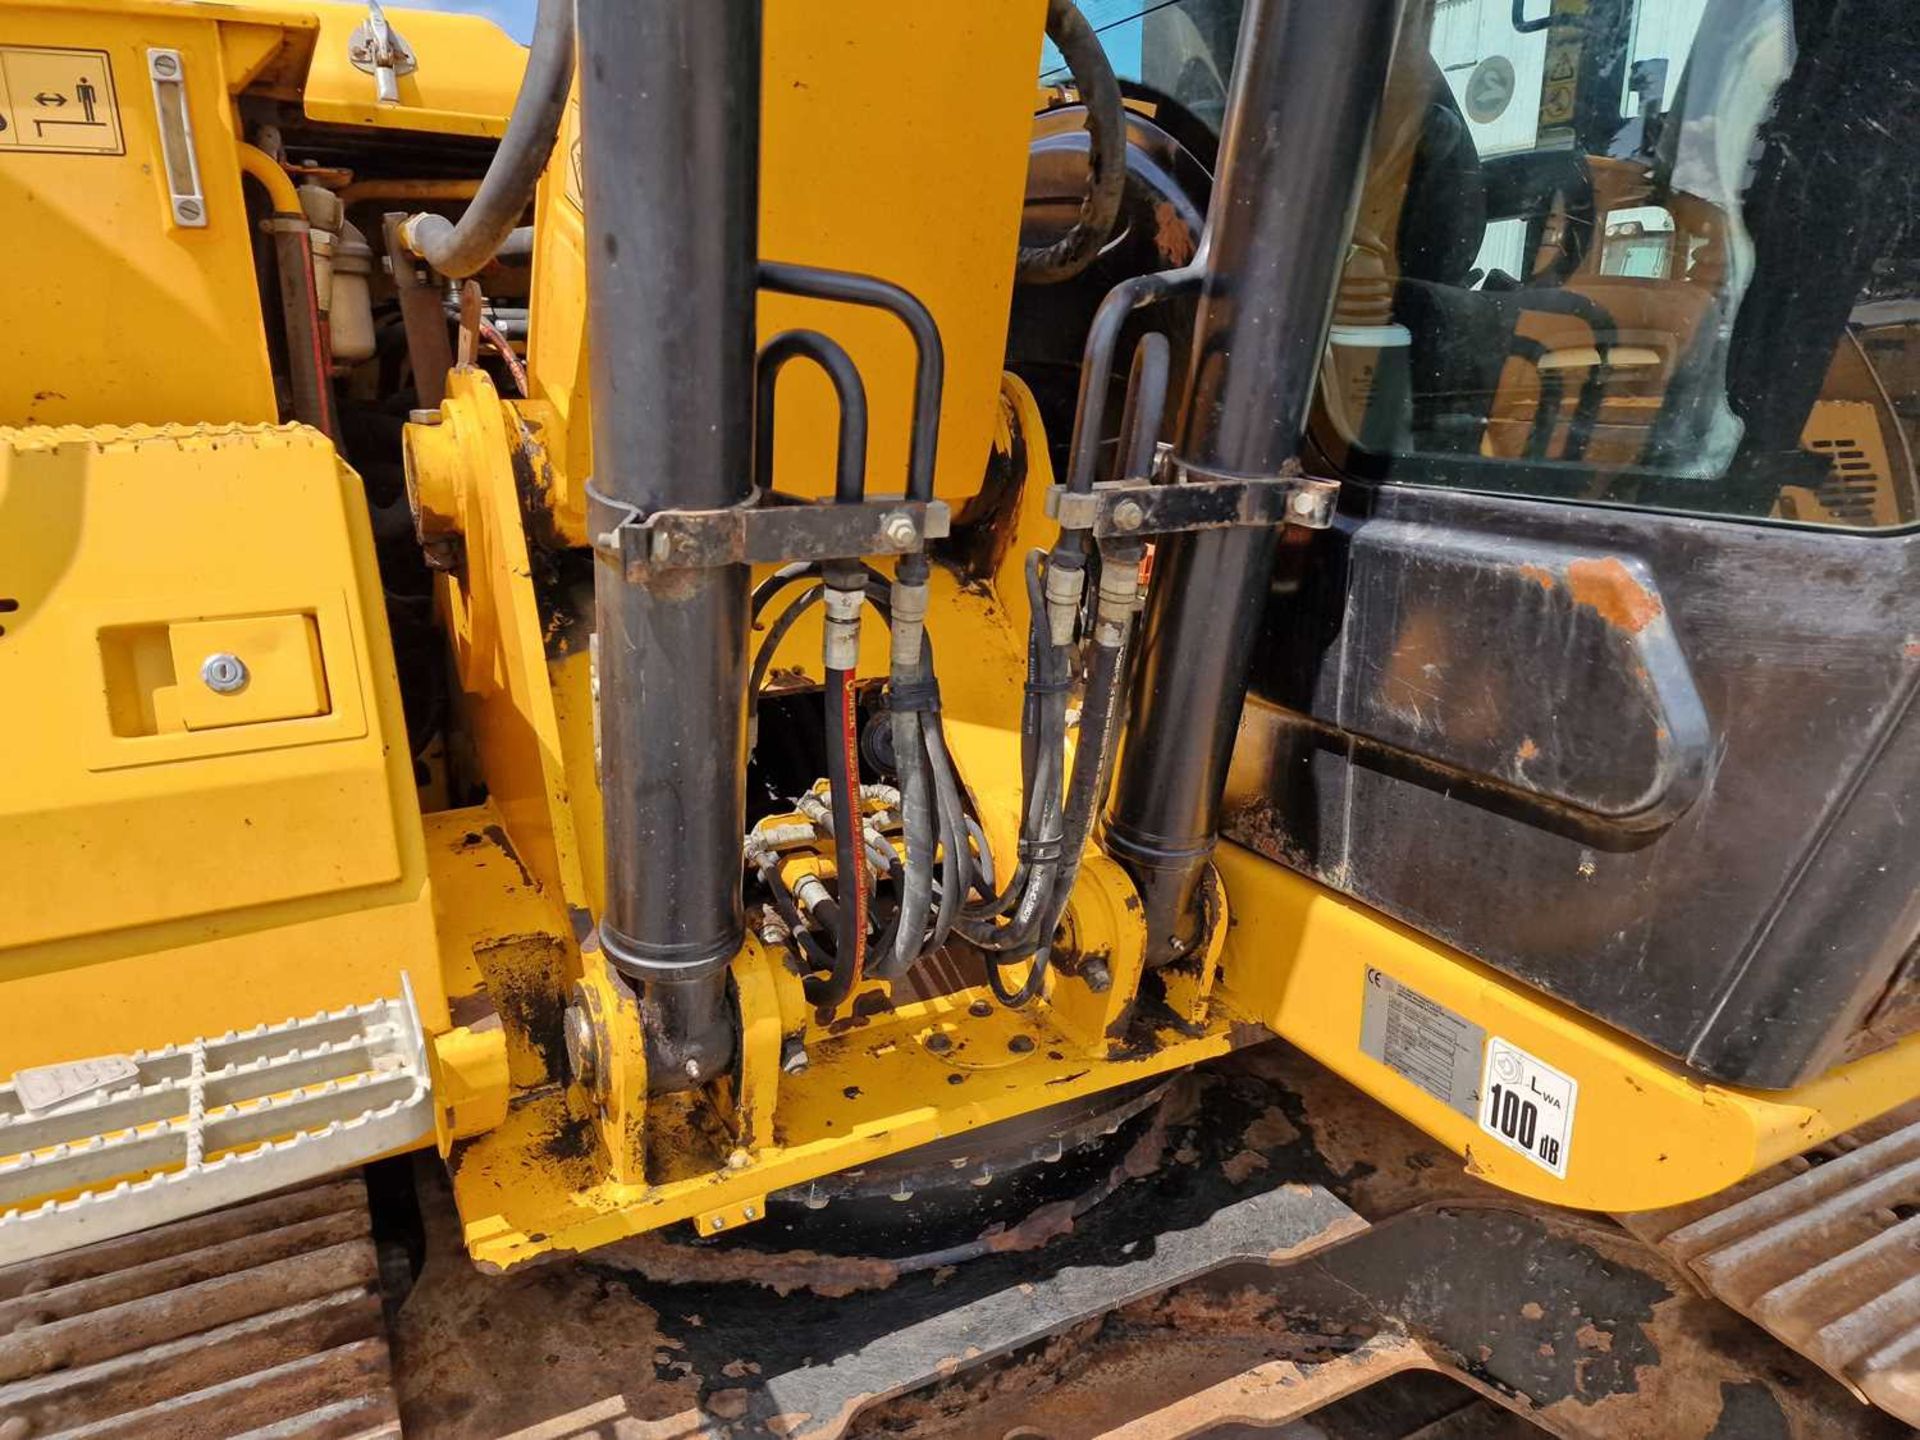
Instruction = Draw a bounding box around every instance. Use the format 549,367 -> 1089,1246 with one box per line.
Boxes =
1624,1106 -> 1920,1425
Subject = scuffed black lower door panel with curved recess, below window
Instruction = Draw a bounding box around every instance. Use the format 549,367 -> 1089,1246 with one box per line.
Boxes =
1229,486 -> 1920,1087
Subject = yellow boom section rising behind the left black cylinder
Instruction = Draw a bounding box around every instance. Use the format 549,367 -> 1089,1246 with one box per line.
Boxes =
528,0 -> 1046,543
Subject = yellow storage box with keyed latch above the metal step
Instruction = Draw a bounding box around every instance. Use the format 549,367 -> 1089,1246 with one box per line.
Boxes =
0,426 -> 445,1073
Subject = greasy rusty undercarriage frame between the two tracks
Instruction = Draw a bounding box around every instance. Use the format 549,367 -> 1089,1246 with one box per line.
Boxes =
396,1044 -> 1903,1440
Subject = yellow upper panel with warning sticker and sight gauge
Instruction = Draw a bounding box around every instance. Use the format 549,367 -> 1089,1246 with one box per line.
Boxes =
0,4 -> 278,424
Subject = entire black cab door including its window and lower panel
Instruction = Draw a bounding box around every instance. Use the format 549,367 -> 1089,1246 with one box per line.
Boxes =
1227,0 -> 1920,1087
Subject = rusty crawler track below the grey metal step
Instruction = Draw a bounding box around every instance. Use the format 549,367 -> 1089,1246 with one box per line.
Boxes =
0,1175 -> 399,1440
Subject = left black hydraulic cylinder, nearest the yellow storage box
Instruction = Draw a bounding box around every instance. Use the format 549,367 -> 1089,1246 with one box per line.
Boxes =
580,0 -> 760,1091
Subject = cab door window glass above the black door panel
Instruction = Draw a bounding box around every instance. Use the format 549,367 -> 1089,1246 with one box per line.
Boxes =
1320,0 -> 1920,528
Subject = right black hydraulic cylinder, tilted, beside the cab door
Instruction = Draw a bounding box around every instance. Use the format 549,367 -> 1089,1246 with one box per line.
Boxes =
1106,0 -> 1400,964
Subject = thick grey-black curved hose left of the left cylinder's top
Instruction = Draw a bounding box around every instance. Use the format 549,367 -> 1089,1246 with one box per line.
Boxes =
403,0 -> 574,280
